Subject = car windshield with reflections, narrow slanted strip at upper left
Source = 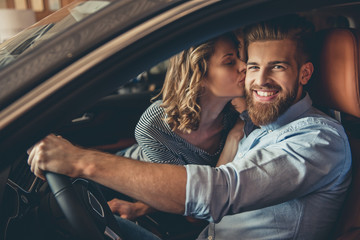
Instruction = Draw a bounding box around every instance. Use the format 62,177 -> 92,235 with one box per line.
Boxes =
0,0 -> 110,69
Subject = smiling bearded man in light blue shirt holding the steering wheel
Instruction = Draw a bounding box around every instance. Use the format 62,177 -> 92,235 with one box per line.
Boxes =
29,17 -> 351,240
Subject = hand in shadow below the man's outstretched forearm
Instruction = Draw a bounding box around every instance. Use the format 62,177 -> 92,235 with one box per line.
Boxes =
108,198 -> 154,220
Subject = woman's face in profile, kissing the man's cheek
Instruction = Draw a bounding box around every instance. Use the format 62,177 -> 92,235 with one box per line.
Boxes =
204,37 -> 246,100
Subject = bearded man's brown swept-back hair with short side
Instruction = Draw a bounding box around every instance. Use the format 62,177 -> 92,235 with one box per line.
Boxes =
244,15 -> 315,67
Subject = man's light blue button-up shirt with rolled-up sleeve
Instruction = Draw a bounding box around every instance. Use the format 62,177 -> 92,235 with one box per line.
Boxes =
185,95 -> 351,240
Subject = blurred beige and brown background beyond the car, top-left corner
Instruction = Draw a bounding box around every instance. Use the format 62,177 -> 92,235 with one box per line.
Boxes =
0,0 -> 77,43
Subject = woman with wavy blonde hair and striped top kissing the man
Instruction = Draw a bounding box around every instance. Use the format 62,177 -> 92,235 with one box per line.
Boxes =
109,31 -> 246,219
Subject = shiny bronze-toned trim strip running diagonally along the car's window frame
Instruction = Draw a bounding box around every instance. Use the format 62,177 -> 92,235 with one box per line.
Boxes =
0,0 -> 220,130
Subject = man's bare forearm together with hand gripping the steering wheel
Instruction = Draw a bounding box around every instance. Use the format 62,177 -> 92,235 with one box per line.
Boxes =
28,134 -> 186,214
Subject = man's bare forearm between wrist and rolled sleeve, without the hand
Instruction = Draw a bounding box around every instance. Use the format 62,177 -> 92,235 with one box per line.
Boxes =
79,150 -> 186,214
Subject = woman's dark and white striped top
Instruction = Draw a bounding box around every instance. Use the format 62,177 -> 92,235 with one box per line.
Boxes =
117,100 -> 239,166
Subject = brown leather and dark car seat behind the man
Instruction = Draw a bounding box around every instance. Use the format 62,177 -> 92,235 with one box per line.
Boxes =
308,28 -> 360,240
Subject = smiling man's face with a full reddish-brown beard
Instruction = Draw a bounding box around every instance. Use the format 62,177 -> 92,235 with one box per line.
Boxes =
245,39 -> 302,125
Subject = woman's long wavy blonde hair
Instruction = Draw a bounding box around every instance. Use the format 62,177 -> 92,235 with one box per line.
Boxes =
155,33 -> 238,133
